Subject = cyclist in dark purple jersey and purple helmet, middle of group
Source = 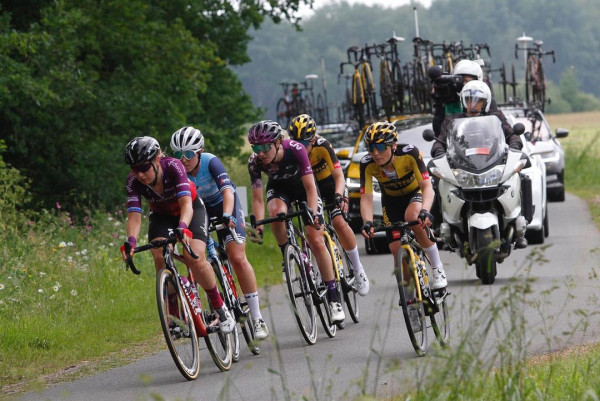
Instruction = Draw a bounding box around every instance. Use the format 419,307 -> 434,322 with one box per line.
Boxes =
248,120 -> 345,322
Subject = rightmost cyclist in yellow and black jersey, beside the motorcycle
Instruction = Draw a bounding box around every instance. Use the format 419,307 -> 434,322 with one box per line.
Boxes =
360,122 -> 448,290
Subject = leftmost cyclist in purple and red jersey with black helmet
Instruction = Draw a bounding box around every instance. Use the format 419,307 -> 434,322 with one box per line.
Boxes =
121,136 -> 235,333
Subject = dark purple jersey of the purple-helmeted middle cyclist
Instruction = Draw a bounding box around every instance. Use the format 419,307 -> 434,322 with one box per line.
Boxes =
248,139 -> 313,189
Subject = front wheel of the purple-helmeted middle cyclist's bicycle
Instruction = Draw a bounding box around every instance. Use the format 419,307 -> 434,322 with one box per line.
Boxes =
284,244 -> 317,345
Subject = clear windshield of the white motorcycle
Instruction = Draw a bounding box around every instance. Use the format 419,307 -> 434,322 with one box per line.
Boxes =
447,116 -> 506,171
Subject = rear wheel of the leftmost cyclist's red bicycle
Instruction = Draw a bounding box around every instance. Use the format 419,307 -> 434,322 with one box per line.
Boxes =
198,278 -> 232,372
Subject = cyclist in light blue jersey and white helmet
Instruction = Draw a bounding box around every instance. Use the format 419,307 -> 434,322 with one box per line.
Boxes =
171,127 -> 269,340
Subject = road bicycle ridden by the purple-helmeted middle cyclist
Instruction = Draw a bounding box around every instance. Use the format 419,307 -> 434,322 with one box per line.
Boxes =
250,202 -> 337,345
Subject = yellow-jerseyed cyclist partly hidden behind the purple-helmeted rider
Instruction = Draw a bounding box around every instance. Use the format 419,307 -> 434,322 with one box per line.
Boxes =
288,114 -> 369,296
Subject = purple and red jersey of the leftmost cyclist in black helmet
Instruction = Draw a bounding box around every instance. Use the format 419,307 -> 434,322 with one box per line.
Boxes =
125,157 -> 197,216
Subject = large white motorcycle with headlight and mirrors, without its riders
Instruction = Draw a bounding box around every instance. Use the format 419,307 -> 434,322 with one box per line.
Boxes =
423,116 -> 531,284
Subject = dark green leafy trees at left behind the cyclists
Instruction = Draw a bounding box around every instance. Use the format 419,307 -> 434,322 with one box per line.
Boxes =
0,0 -> 312,211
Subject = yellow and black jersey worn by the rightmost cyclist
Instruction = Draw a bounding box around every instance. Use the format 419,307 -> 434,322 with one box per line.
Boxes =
360,144 -> 429,201
